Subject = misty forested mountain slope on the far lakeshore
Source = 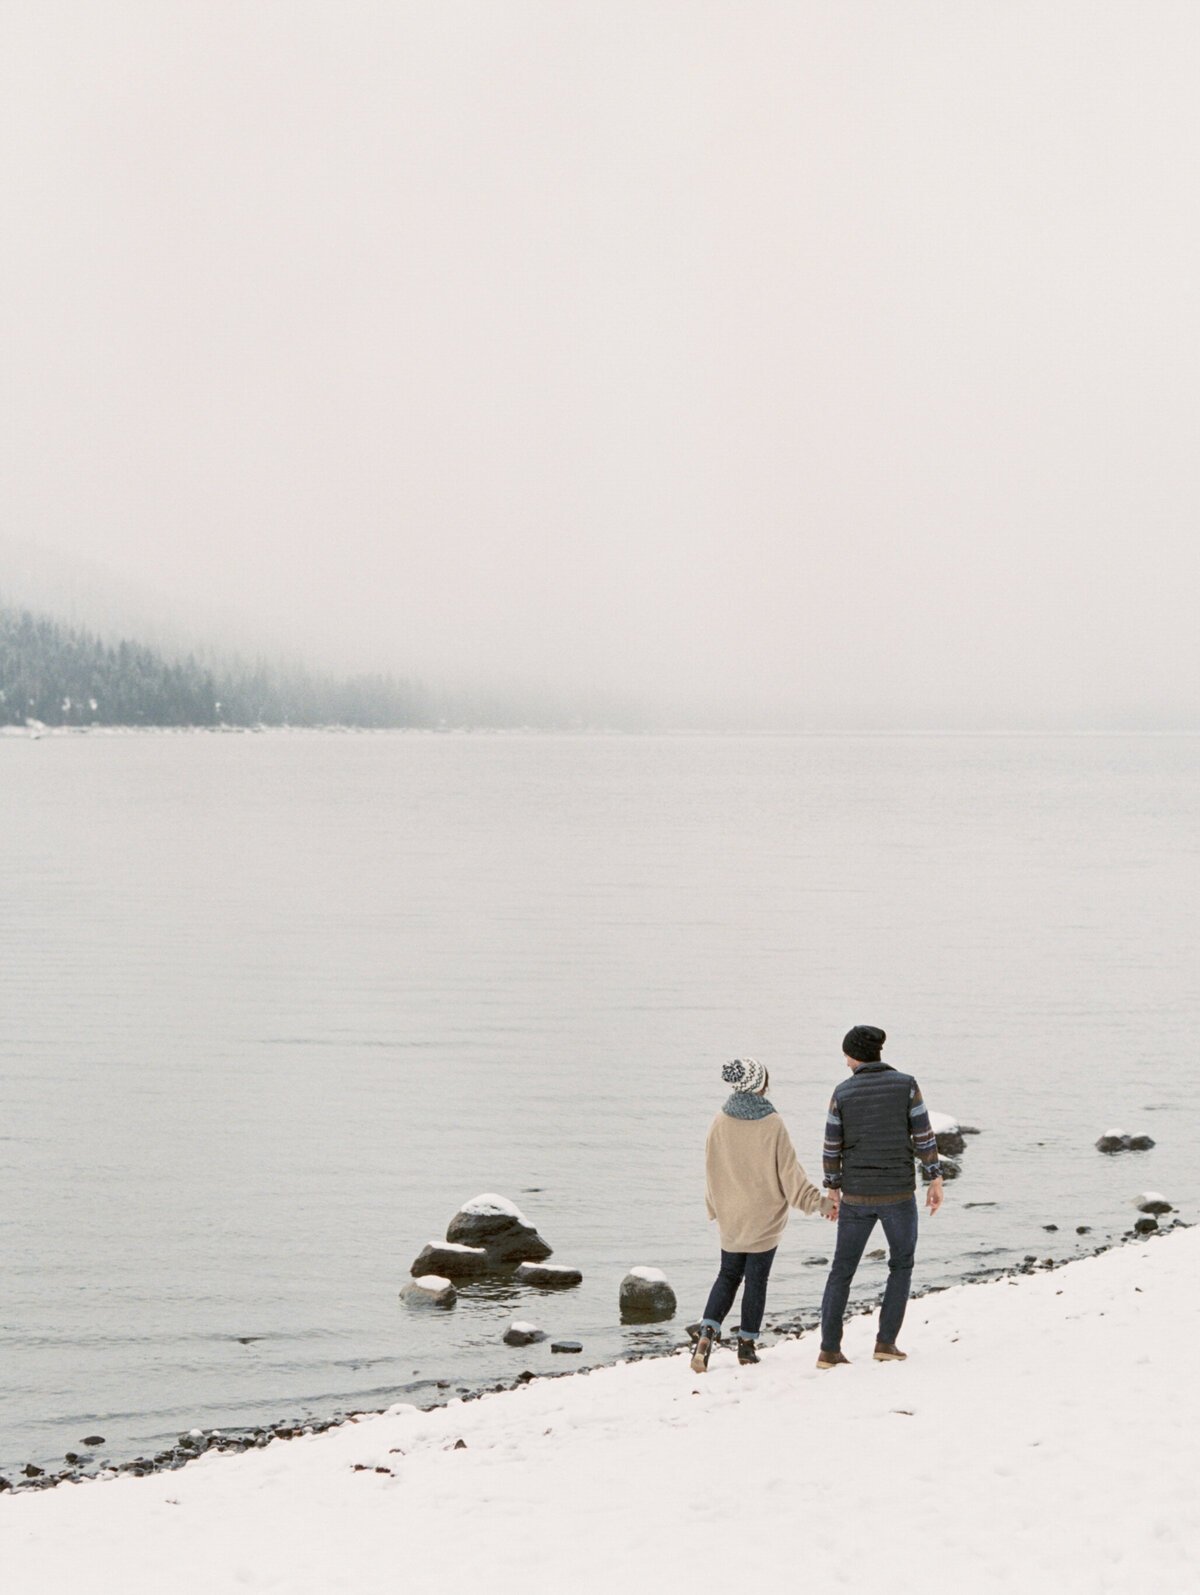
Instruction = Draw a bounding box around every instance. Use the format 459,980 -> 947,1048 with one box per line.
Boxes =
0,608 -> 448,729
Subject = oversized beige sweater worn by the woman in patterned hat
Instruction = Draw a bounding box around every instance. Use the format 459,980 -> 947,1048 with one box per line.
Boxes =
704,1113 -> 828,1252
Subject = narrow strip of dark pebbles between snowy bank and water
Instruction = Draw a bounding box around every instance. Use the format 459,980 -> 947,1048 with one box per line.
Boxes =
0,1215 -> 1190,1495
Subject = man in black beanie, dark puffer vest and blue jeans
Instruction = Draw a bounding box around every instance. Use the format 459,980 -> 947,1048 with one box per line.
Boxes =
817,1024 -> 941,1369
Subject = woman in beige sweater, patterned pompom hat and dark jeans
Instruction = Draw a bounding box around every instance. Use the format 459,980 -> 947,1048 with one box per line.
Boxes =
691,1057 -> 833,1373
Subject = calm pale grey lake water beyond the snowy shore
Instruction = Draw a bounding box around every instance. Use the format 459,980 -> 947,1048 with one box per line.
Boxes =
0,732 -> 1200,1472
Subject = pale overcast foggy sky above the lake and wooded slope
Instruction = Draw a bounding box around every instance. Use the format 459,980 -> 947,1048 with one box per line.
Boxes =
0,0 -> 1200,727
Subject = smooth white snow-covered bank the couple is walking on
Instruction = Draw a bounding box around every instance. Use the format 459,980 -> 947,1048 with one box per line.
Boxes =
0,1228 -> 1200,1595
